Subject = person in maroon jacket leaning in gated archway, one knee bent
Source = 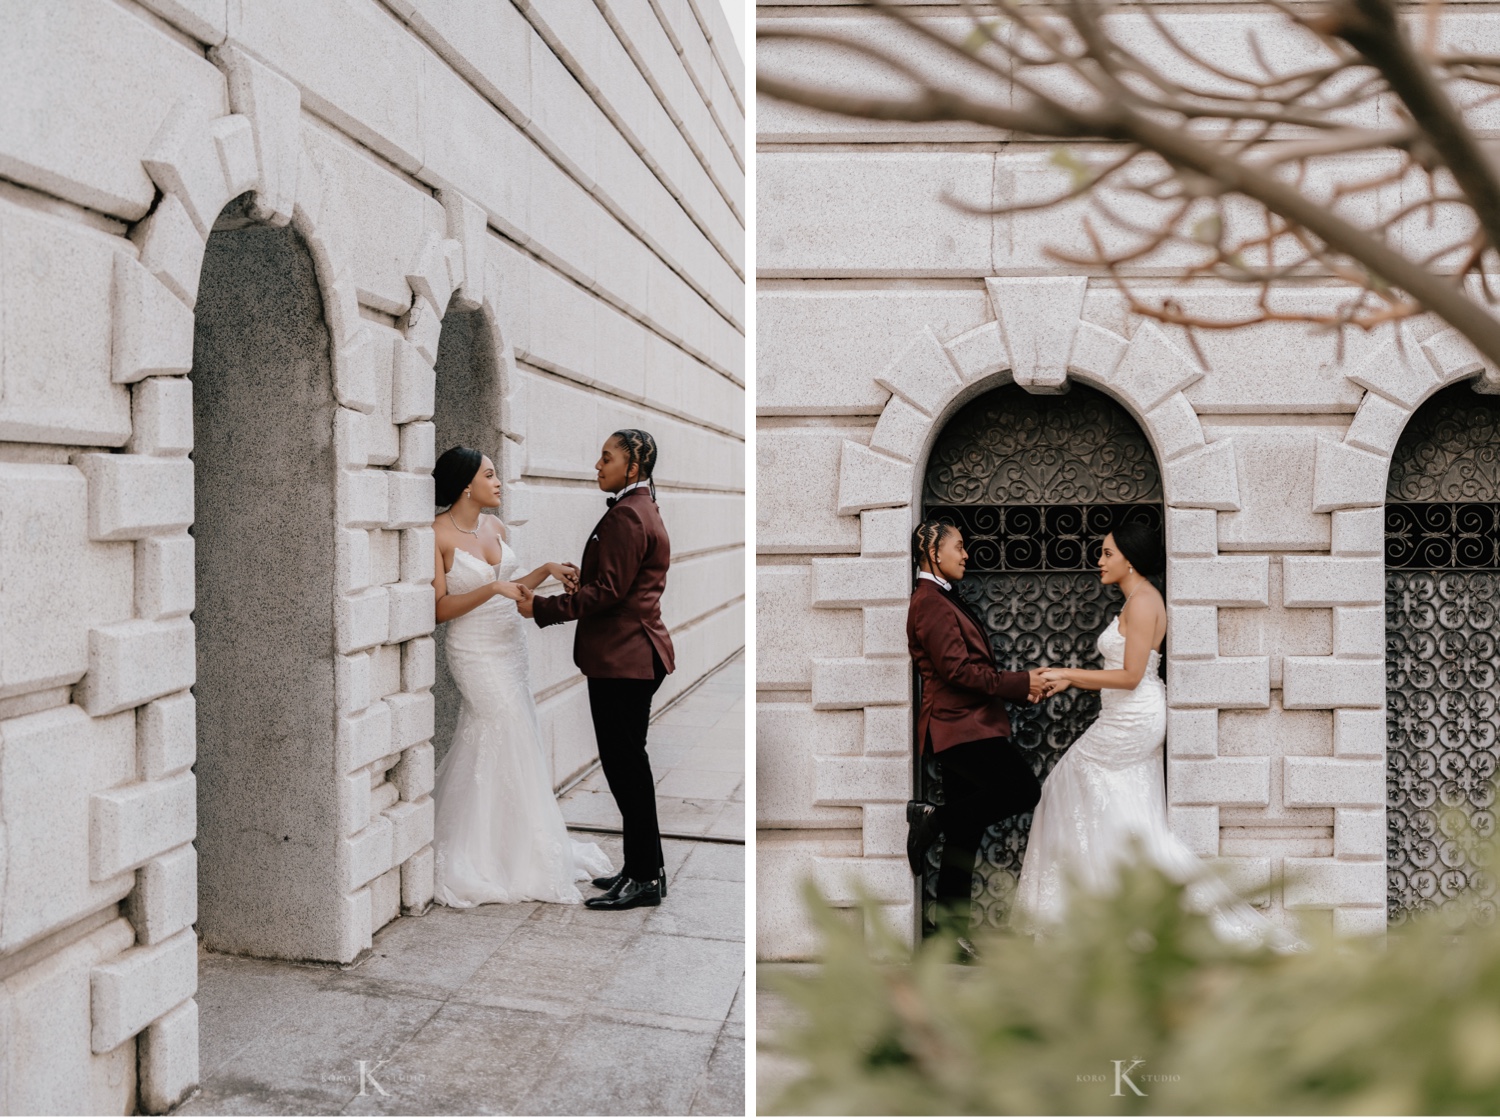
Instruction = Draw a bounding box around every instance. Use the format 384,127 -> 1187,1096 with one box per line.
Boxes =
906,521 -> 1043,932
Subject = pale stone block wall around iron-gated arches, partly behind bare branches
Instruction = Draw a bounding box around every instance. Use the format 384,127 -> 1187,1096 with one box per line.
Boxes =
756,0 -> 1500,959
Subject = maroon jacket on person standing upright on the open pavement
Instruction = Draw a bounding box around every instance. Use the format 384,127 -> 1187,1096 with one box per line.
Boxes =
534,488 -> 677,680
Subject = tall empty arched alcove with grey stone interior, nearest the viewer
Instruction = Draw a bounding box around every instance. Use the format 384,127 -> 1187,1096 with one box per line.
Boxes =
192,198 -> 347,959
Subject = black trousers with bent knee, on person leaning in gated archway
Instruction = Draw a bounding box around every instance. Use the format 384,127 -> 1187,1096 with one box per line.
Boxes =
938,737 -> 1041,920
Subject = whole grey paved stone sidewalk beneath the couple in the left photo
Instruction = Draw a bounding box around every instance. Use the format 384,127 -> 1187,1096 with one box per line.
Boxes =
177,660 -> 746,1115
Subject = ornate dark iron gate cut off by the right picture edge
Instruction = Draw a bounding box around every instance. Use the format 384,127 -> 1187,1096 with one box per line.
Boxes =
1386,384 -> 1500,924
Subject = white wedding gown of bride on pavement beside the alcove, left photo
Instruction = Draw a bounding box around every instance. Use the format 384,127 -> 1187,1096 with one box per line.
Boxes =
432,543 -> 614,908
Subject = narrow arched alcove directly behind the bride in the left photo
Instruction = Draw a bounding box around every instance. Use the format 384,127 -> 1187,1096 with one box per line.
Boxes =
432,306 -> 506,761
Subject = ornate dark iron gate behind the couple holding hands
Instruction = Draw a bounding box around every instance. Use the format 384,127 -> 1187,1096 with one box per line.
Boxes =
917,386 -> 1161,930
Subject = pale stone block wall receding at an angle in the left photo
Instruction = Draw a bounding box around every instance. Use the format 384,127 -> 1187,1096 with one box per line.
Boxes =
0,0 -> 746,1113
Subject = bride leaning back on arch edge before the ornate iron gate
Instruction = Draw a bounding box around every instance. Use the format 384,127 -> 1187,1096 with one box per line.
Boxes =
1011,524 -> 1293,947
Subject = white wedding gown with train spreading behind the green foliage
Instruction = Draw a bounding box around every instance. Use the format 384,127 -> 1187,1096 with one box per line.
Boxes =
1011,617 -> 1293,947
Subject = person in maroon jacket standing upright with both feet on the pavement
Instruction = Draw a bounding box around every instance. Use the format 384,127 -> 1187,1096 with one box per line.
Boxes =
518,429 -> 675,909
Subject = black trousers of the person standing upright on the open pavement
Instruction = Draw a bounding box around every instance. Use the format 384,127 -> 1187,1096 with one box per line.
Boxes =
588,654 -> 666,881
